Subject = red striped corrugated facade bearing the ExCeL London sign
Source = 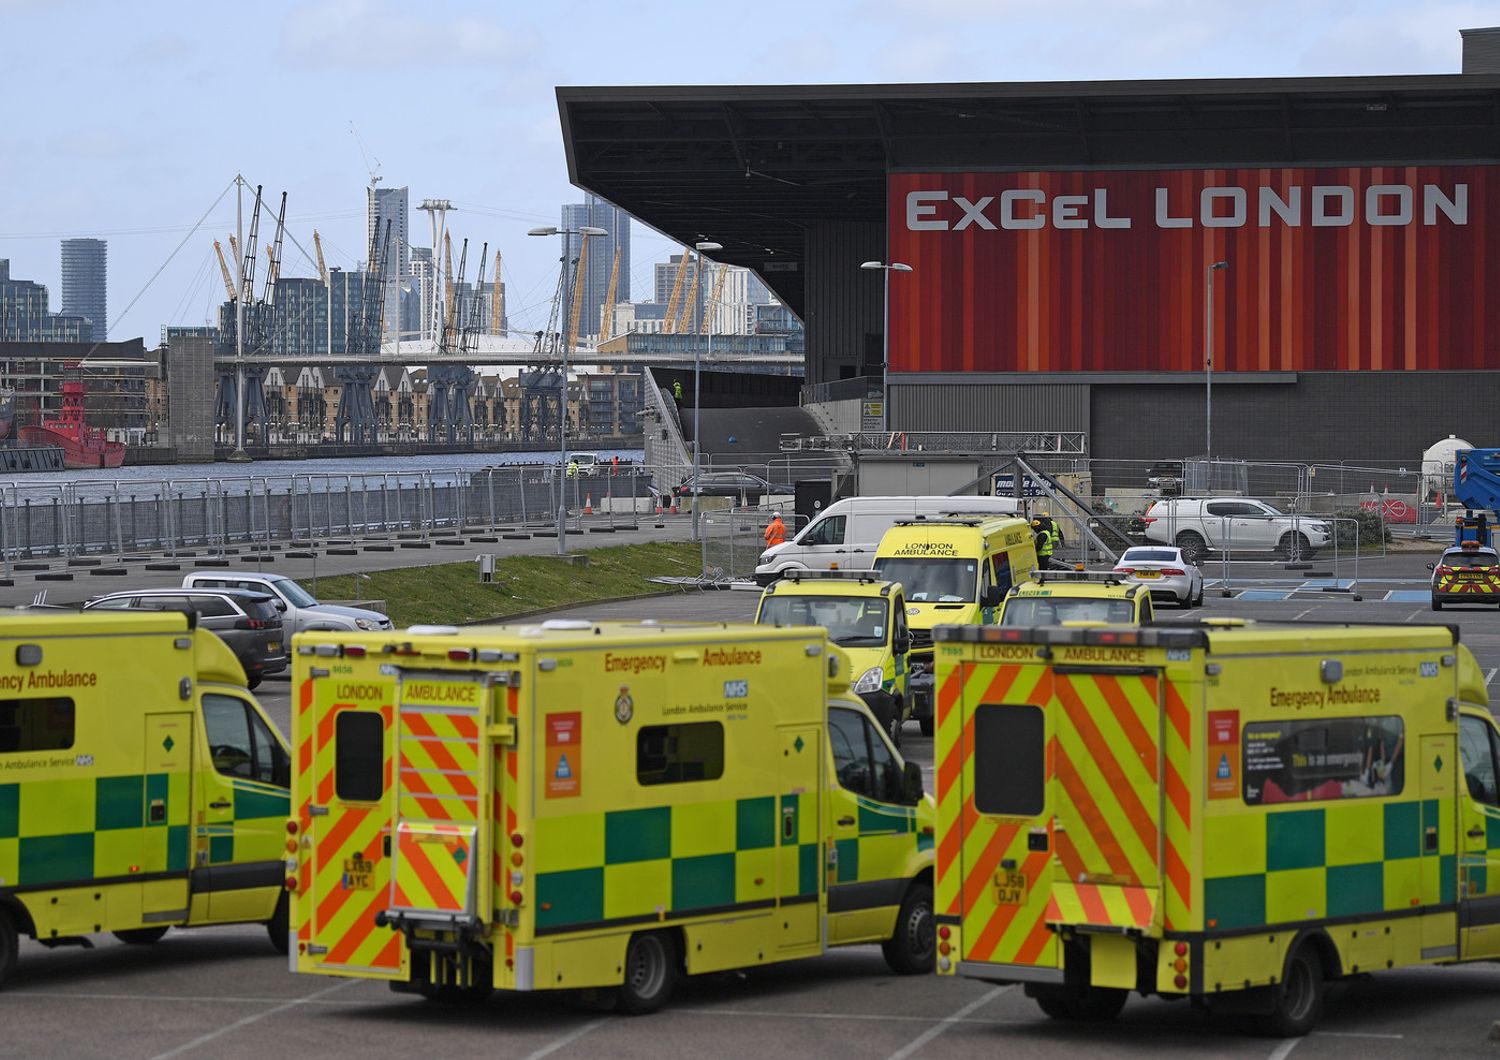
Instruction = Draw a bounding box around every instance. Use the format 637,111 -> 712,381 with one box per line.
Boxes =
888,165 -> 1500,372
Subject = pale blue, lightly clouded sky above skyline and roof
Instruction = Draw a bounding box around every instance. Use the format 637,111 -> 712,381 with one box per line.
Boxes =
0,0 -> 1500,346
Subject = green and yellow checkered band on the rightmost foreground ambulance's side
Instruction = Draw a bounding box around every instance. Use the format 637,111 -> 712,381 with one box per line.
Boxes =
1203,799 -> 1458,931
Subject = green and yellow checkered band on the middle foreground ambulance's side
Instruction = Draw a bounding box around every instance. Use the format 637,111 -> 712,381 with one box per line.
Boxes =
536,795 -> 822,933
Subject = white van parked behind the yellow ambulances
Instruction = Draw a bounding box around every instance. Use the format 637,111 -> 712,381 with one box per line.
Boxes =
755,496 -> 1020,585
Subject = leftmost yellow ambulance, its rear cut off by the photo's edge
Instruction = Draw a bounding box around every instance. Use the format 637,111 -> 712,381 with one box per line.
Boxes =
0,610 -> 291,984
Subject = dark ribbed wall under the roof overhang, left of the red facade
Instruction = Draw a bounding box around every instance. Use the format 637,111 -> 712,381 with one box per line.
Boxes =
803,222 -> 882,382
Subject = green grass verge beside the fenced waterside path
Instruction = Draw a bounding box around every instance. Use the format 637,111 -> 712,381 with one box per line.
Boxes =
309,541 -> 699,627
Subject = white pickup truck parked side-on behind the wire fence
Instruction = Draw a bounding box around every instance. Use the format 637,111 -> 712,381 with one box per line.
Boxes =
1142,496 -> 1334,565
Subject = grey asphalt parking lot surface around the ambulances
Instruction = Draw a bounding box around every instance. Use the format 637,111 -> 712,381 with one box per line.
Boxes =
11,556 -> 1500,1060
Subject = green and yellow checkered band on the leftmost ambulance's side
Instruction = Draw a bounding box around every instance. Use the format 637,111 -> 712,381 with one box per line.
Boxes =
0,774 -> 193,889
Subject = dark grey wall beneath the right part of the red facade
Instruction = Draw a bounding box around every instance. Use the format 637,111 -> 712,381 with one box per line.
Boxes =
1089,372 -> 1500,468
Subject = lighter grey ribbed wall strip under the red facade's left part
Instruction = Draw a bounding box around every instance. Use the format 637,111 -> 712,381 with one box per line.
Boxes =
891,376 -> 1089,432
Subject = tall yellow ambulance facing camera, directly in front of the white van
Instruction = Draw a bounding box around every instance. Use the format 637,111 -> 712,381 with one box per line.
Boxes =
873,516 -> 1037,736
